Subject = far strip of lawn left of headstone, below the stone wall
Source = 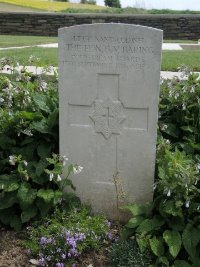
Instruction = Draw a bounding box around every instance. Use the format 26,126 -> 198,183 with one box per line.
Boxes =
0,35 -> 58,47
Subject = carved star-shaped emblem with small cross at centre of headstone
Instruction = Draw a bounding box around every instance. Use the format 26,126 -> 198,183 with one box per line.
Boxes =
89,98 -> 126,139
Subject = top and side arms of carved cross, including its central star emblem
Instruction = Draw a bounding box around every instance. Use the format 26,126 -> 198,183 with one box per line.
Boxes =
69,74 -> 148,139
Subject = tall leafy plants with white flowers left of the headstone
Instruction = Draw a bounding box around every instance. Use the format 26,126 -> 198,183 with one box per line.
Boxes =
0,57 -> 77,230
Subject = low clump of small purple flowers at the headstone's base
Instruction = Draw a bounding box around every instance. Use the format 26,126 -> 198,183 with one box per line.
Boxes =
25,206 -> 110,267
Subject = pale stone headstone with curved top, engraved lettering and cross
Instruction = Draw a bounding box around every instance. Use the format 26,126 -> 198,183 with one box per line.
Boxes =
58,24 -> 162,219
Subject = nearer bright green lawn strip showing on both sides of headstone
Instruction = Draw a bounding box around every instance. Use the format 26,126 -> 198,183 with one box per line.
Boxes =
0,47 -> 200,71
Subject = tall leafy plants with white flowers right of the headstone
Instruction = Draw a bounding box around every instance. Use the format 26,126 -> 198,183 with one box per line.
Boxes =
124,70 -> 200,267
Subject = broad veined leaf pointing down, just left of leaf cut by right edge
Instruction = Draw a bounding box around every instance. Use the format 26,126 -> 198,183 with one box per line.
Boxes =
163,230 -> 182,258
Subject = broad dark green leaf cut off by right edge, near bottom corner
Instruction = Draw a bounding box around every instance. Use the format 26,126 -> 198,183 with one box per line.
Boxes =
182,225 -> 200,258
